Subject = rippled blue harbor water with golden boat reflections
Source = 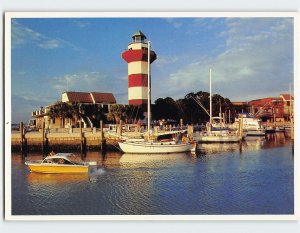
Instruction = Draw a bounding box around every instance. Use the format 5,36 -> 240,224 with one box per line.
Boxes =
11,133 -> 294,215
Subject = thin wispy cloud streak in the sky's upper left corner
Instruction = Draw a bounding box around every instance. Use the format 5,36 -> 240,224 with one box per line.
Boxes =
11,19 -> 78,50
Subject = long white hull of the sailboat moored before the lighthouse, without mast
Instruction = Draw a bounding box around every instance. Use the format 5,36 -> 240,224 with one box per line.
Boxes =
119,142 -> 193,154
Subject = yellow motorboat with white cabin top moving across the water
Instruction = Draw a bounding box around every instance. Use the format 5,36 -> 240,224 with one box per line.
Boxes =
25,153 -> 97,173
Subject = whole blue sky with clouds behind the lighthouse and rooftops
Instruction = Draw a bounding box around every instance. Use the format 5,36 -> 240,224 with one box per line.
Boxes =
11,17 -> 294,123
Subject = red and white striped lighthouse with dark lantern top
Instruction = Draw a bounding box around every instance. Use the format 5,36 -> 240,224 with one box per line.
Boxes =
122,31 -> 156,106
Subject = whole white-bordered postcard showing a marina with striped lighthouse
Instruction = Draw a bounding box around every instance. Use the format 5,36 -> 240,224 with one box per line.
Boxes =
5,14 -> 297,219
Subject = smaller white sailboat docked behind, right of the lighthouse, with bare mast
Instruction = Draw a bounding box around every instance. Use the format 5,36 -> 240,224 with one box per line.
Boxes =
194,69 -> 241,143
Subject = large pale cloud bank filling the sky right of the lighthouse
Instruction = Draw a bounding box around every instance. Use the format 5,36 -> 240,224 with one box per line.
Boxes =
164,18 -> 293,100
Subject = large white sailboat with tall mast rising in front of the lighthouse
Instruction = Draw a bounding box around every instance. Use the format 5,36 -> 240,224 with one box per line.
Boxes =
119,41 -> 194,154
